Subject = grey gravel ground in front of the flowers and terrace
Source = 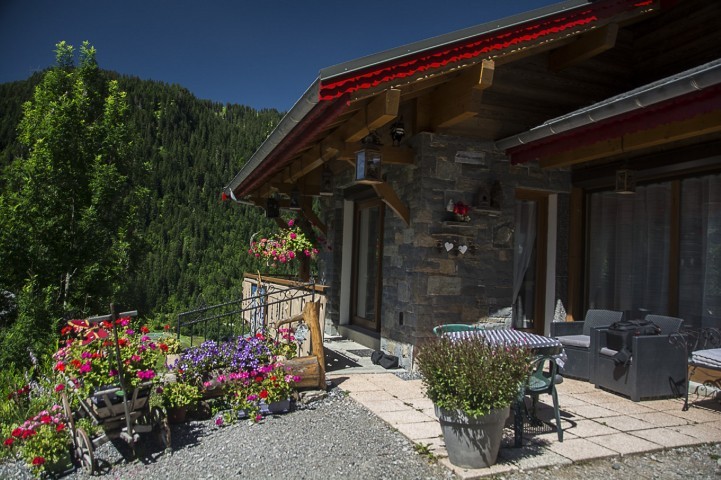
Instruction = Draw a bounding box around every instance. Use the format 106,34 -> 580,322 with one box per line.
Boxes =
0,382 -> 721,480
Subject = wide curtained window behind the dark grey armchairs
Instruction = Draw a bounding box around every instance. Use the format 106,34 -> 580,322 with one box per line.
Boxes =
586,175 -> 721,327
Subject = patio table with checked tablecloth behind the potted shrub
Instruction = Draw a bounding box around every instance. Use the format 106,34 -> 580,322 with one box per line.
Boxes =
445,329 -> 565,447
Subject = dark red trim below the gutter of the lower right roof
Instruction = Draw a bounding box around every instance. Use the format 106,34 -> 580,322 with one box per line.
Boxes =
508,86 -> 721,164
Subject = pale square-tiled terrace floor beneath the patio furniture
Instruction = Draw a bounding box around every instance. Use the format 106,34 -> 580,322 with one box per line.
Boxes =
325,340 -> 721,479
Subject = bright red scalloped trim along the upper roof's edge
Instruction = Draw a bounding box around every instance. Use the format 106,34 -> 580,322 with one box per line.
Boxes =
319,0 -> 655,100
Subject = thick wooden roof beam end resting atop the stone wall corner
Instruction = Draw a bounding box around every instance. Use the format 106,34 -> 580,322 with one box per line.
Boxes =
431,60 -> 495,130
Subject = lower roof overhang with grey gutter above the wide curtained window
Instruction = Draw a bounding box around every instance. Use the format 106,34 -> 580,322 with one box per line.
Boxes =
496,58 -> 721,168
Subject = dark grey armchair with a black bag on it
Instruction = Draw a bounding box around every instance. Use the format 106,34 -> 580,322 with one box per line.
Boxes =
592,315 -> 687,402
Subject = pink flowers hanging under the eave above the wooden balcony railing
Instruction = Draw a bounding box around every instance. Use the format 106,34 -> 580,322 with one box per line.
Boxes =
248,219 -> 318,266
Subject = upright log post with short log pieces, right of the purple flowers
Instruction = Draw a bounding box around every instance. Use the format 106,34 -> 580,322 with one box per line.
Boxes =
275,302 -> 326,390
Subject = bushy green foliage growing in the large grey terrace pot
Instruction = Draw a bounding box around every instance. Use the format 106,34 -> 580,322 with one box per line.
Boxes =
416,336 -> 531,416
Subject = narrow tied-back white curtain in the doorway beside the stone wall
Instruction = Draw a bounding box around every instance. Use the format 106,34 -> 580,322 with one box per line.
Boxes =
513,201 -> 537,328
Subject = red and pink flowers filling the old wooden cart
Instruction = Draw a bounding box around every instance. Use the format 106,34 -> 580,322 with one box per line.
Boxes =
53,318 -> 169,397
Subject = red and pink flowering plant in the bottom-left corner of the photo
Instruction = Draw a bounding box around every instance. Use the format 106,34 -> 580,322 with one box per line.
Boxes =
4,404 -> 71,476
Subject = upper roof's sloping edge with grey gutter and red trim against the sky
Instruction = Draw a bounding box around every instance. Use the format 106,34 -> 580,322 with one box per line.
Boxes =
225,0 -> 660,198
